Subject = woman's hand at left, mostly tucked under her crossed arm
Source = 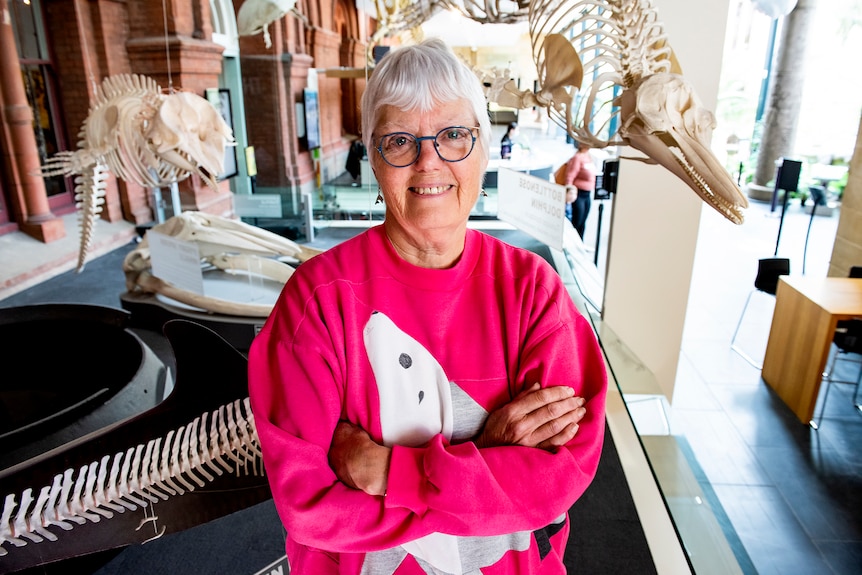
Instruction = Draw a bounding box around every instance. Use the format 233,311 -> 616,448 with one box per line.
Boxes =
329,421 -> 392,495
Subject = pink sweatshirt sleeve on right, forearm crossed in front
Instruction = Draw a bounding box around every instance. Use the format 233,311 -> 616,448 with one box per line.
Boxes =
386,306 -> 607,535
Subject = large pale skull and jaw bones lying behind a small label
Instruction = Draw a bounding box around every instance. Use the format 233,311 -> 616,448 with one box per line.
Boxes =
123,211 -> 320,317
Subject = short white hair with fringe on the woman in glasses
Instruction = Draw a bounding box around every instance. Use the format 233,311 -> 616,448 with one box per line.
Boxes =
361,38 -> 491,159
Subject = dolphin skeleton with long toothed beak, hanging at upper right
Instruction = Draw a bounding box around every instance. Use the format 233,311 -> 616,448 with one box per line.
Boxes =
490,0 -> 748,224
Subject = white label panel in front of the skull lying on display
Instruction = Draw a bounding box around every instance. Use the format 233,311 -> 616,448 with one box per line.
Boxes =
147,230 -> 204,295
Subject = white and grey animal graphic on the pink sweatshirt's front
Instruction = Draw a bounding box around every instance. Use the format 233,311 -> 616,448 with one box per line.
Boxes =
362,312 -> 532,575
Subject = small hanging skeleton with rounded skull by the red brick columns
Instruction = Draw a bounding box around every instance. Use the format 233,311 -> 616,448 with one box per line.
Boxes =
39,74 -> 233,271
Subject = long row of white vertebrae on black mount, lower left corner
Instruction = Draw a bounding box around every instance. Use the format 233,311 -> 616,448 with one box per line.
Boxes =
0,397 -> 264,557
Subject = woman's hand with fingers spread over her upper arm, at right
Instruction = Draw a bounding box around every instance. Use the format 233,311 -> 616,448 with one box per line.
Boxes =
476,383 -> 586,451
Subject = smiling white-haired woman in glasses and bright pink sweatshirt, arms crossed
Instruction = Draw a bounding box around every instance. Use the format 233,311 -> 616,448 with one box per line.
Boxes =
249,40 -> 606,575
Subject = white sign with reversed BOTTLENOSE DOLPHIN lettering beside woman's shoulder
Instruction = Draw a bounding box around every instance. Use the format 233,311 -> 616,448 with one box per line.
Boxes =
497,167 -> 566,250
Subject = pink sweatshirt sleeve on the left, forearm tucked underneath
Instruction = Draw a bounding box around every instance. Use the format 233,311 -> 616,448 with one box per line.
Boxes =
249,318 -> 430,553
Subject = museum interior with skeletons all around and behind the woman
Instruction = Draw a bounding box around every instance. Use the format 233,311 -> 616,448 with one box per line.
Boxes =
0,0 -> 862,575
